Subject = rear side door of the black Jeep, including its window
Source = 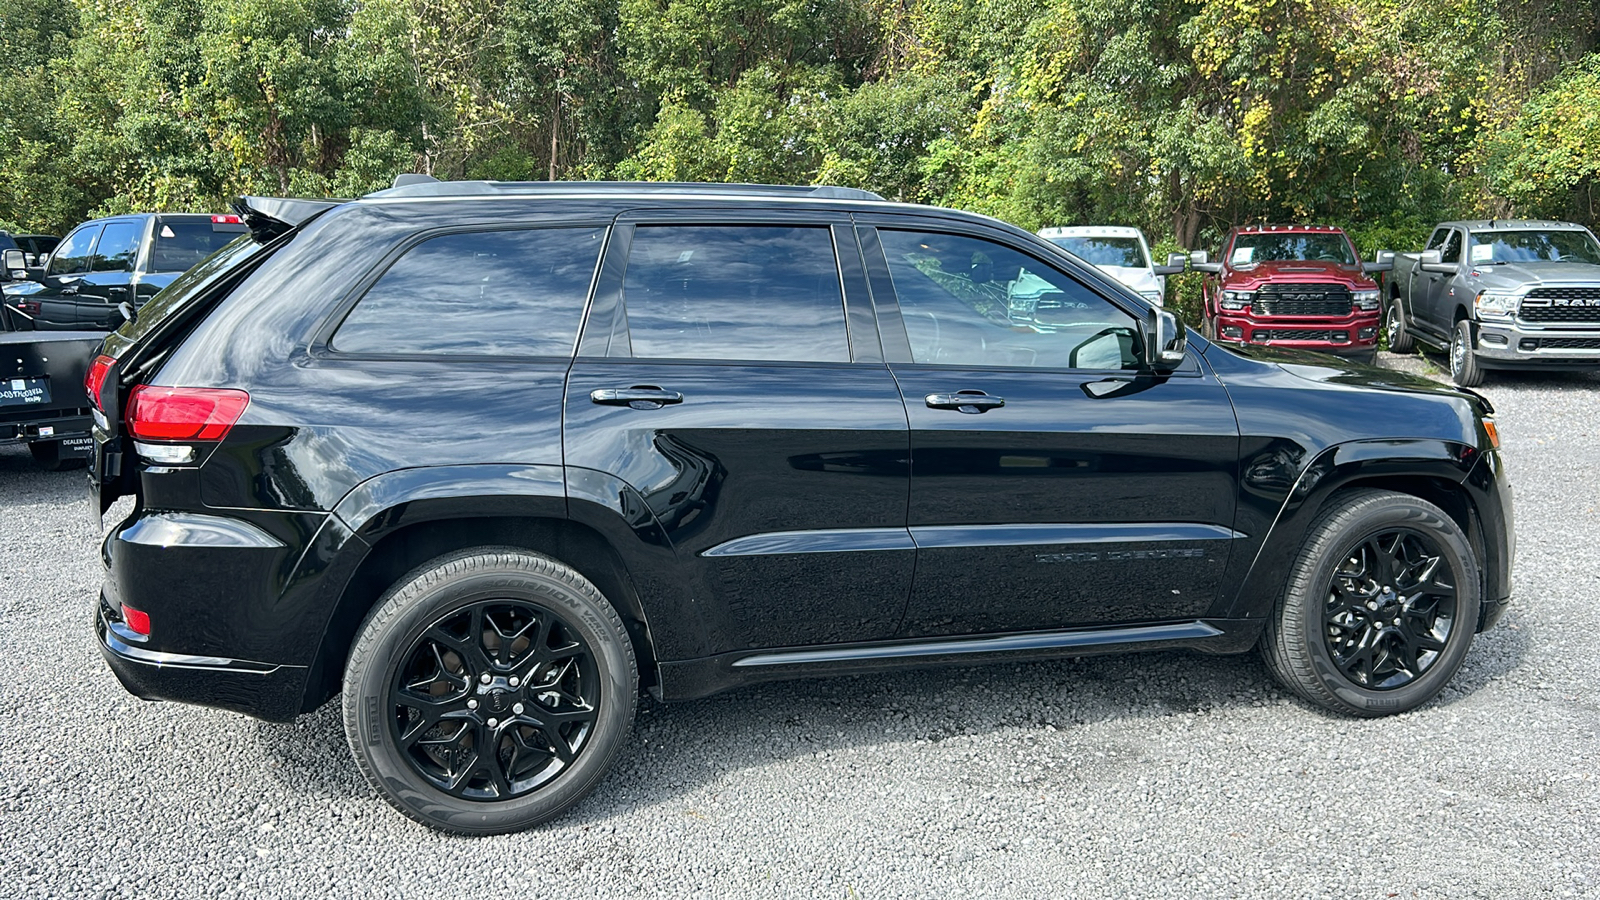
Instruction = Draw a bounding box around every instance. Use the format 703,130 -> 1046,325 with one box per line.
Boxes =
565,210 -> 915,655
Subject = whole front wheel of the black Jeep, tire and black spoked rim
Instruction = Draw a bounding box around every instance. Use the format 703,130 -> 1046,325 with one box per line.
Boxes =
1261,490 -> 1480,717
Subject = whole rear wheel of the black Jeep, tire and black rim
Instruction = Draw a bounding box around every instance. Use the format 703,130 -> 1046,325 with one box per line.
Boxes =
344,548 -> 638,834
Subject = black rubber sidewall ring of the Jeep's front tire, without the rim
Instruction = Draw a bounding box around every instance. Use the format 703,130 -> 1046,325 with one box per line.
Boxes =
1299,503 -> 1480,716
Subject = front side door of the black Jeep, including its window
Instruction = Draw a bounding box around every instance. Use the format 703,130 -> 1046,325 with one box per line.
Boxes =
862,219 -> 1240,637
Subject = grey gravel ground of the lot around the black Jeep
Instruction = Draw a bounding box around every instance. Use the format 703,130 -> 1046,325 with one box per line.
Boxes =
0,357 -> 1600,900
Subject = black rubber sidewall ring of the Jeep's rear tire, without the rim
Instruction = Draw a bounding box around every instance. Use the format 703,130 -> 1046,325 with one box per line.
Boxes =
344,557 -> 637,833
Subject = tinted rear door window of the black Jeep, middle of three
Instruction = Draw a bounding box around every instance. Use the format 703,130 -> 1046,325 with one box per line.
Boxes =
622,226 -> 850,362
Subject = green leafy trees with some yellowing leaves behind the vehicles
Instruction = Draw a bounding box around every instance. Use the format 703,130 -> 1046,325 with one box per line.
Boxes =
0,0 -> 1600,243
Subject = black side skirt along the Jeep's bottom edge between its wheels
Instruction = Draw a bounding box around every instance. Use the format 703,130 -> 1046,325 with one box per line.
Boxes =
653,618 -> 1264,700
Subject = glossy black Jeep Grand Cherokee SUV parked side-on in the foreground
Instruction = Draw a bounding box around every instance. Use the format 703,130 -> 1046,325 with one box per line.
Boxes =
90,183 -> 1512,833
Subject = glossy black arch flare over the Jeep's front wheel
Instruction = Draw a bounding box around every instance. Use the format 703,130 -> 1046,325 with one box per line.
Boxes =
1226,439 -> 1478,618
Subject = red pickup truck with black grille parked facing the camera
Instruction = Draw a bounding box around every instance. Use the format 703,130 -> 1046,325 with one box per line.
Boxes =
1190,226 -> 1394,362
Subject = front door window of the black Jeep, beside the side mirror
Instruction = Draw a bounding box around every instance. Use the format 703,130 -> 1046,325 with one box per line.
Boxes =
880,231 -> 1141,368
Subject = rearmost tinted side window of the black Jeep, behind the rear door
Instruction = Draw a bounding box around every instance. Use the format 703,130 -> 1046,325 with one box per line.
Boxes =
333,227 -> 605,356
